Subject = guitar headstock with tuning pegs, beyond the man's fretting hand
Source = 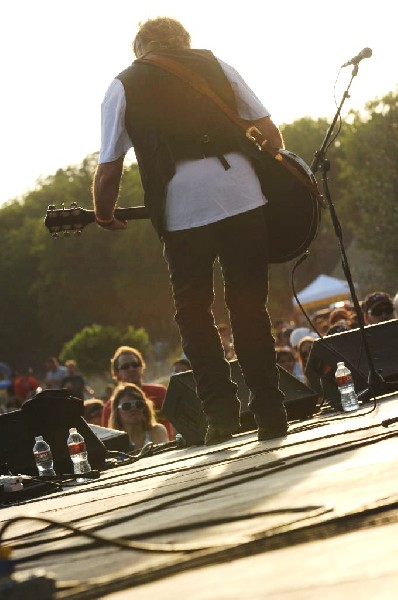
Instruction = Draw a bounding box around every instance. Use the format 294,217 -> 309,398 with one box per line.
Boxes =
44,202 -> 95,238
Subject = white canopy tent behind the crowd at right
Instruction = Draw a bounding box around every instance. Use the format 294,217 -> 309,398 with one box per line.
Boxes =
293,275 -> 351,309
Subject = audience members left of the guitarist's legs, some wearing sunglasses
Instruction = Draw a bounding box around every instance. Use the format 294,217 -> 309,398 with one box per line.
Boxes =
0,346 -> 191,450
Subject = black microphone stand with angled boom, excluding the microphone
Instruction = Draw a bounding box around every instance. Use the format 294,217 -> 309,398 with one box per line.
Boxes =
311,64 -> 398,402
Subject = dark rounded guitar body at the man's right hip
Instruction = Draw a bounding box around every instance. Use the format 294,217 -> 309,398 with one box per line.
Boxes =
255,150 -> 321,263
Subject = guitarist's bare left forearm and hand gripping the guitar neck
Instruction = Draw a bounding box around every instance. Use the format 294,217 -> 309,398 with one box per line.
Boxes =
93,155 -> 127,231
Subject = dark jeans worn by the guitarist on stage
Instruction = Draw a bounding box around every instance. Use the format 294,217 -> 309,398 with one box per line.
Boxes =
164,208 -> 283,428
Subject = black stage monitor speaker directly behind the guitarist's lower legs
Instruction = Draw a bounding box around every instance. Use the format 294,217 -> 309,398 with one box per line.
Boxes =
162,360 -> 318,444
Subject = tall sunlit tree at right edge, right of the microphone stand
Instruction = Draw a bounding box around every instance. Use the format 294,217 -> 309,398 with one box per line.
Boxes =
340,92 -> 398,293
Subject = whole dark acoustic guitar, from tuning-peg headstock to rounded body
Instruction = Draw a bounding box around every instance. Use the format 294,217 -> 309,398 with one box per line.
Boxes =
44,150 -> 321,263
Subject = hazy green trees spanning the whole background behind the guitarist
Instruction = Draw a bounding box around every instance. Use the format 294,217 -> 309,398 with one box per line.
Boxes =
0,93 -> 398,374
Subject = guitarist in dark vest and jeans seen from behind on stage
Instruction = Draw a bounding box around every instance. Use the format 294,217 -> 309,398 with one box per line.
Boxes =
93,18 -> 287,445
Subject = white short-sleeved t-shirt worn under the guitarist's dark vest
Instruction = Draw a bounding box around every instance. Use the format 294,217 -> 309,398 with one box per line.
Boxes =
98,59 -> 270,231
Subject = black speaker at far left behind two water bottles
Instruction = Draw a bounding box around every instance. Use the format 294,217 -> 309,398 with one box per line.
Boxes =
0,390 -> 106,475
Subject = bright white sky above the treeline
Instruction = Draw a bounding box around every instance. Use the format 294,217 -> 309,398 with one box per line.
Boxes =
0,0 -> 398,204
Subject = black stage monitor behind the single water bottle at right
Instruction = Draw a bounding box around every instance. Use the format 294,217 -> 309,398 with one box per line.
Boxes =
305,319 -> 398,408
